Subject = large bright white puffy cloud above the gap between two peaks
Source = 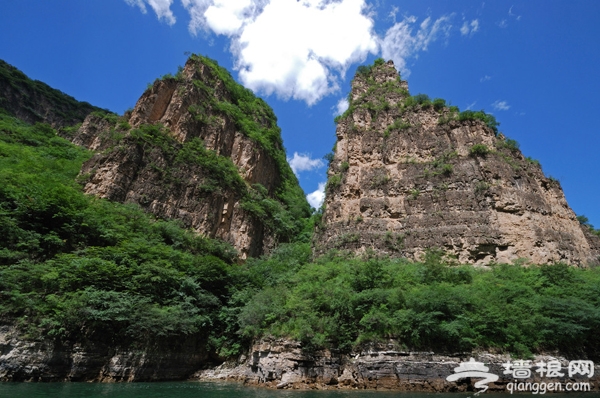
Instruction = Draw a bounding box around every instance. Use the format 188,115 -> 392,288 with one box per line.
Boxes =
232,0 -> 377,105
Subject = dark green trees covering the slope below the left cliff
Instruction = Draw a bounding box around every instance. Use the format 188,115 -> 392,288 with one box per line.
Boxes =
0,109 -> 240,344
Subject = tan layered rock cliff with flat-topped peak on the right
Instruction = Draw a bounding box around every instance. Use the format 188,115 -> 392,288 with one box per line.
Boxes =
315,61 -> 600,265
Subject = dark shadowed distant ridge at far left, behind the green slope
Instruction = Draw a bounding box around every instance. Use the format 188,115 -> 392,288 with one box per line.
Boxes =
0,60 -> 105,128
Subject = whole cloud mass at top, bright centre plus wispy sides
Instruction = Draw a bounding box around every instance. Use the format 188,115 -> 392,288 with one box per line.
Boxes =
125,0 -> 468,105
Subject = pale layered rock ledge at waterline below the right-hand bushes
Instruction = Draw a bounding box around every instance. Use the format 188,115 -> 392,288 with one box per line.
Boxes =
194,339 -> 600,392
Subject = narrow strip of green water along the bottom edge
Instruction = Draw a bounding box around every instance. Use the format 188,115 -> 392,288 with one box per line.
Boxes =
0,382 -> 598,398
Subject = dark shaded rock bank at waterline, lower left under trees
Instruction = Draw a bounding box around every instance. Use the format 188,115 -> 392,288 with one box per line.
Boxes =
0,325 -> 208,382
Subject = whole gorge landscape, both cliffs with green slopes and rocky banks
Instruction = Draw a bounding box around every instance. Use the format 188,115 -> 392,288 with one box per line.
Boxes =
0,55 -> 600,392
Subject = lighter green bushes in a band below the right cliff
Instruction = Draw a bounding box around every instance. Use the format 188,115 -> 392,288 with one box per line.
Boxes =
239,249 -> 600,357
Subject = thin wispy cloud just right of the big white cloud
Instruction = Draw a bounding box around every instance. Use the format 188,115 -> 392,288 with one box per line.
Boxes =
381,14 -> 453,77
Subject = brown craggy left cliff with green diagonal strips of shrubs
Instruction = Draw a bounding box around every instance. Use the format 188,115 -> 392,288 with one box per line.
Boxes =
73,56 -> 309,259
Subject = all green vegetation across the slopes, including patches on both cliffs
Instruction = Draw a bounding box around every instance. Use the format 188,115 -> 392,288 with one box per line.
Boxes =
0,56 -> 600,364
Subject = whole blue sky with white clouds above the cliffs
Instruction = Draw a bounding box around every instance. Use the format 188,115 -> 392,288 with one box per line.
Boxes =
0,0 -> 600,227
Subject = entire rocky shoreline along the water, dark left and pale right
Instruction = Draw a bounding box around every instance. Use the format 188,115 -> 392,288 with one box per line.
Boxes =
0,326 -> 600,392
